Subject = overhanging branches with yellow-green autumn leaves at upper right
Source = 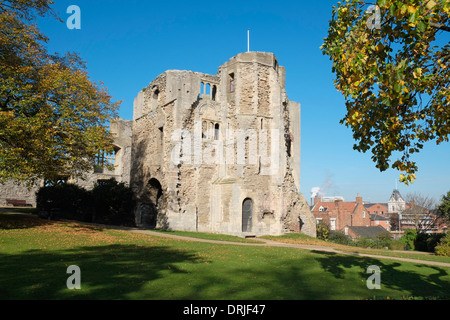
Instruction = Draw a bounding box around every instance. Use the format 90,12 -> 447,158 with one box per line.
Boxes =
321,0 -> 450,184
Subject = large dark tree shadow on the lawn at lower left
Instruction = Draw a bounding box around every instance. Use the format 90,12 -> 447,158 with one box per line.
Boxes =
0,245 -> 199,300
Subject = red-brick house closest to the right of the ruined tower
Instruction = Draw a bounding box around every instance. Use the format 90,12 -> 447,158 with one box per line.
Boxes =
311,194 -> 371,230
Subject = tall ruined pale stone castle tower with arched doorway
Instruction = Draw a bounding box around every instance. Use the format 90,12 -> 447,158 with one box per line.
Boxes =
131,52 -> 315,236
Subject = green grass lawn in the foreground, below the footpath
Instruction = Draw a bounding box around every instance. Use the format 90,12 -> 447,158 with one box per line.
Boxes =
0,213 -> 450,300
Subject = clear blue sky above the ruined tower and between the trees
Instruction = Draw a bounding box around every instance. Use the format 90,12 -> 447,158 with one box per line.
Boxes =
38,0 -> 450,202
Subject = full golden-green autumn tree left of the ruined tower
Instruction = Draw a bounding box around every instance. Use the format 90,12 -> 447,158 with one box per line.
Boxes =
0,0 -> 119,182
